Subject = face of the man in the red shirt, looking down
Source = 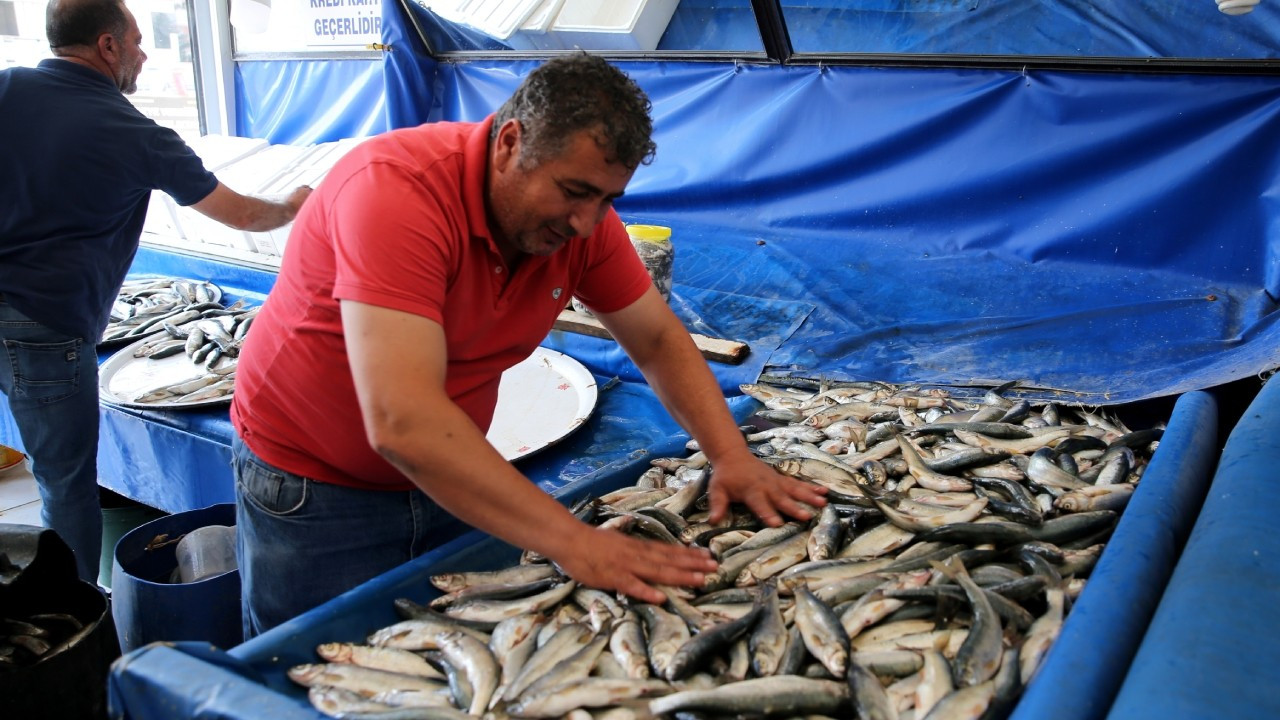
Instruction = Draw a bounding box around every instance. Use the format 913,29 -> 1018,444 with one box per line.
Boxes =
489,120 -> 635,255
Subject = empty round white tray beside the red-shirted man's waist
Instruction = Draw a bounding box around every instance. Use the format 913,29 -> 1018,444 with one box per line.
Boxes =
488,347 -> 596,460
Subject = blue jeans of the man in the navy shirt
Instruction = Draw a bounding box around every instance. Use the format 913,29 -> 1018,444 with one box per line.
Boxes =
0,300 -> 102,583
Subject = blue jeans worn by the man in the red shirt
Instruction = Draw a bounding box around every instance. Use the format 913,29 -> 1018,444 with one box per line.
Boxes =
232,437 -> 467,641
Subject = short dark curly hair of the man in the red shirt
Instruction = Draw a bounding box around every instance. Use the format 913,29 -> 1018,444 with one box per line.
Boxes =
493,53 -> 658,169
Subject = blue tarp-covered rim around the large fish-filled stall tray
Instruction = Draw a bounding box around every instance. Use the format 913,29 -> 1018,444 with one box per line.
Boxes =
109,391 -> 1217,720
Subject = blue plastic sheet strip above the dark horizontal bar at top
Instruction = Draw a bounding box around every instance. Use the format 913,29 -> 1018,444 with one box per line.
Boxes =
399,0 -> 1280,59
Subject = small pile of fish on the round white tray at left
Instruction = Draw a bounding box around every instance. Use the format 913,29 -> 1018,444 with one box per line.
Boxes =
102,278 -> 260,404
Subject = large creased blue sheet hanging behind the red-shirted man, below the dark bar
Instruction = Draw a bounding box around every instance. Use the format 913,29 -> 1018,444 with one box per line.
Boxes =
419,61 -> 1280,404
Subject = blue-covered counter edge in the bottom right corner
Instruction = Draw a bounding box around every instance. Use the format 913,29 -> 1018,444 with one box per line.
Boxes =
1108,377 -> 1280,720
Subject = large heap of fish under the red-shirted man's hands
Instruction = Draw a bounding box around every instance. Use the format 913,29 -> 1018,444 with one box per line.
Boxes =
289,383 -> 1162,720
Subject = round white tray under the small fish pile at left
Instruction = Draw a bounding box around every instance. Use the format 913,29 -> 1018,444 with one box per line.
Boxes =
97,318 -> 232,410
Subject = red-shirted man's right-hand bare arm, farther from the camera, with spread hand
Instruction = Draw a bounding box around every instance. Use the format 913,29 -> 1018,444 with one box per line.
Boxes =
596,287 -> 826,527
